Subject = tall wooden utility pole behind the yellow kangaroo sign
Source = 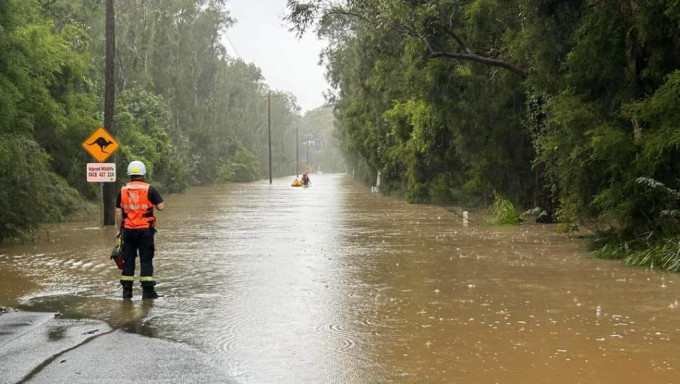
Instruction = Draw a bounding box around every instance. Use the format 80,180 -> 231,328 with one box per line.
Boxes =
102,0 -> 116,225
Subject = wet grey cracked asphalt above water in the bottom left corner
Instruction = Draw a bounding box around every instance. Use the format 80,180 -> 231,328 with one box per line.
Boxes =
0,311 -> 232,383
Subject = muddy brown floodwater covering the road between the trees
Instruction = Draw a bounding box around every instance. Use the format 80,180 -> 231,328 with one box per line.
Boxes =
0,175 -> 680,383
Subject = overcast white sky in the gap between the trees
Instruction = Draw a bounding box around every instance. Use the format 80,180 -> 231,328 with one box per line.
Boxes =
224,0 -> 329,114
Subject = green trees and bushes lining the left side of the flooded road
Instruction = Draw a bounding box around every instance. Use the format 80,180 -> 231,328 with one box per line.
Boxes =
0,0 -> 320,240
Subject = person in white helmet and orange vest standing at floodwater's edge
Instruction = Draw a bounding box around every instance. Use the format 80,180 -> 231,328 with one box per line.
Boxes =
116,161 -> 165,299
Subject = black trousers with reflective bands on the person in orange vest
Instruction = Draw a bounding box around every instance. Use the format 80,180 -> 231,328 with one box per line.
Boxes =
120,228 -> 156,287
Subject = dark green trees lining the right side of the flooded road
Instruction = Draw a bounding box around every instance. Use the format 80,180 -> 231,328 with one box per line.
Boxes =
287,0 -> 680,270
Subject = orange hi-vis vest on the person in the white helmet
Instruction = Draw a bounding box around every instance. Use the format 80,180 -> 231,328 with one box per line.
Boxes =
120,181 -> 156,229
